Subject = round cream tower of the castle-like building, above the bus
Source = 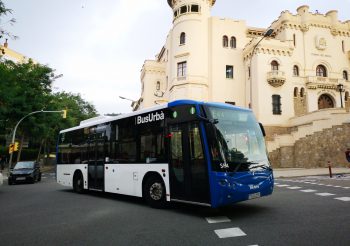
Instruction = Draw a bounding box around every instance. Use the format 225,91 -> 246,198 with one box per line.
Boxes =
166,0 -> 215,101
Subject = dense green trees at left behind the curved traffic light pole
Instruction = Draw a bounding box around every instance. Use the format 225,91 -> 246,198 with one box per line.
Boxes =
0,60 -> 97,160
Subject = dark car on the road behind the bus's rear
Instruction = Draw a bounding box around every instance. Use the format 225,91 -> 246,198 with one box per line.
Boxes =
8,161 -> 41,185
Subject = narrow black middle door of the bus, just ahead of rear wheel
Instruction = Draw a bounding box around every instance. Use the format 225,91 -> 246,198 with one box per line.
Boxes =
88,139 -> 105,191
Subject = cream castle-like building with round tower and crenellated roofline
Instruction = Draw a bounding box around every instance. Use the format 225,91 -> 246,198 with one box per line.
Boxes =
133,0 -> 350,167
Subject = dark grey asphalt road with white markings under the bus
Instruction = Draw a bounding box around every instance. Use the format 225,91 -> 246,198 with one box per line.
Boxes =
0,174 -> 350,246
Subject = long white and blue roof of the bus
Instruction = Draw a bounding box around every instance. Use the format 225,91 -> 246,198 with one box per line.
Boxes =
60,100 -> 251,133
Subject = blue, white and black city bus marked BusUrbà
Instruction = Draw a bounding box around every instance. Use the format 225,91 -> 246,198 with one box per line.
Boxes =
56,100 -> 274,208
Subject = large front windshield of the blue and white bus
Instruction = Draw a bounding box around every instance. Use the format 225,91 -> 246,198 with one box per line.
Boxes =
208,106 -> 270,172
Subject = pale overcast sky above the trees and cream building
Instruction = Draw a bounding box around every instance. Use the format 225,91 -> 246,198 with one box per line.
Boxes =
0,0 -> 350,114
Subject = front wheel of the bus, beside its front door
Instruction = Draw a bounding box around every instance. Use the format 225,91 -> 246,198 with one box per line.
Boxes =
143,175 -> 166,208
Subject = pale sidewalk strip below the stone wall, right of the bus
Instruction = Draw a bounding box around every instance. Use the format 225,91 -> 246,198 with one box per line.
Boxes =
273,167 -> 350,178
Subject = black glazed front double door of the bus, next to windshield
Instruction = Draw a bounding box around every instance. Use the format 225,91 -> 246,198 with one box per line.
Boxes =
169,122 -> 210,204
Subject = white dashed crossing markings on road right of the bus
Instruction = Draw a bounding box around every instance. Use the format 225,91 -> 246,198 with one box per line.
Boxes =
275,178 -> 350,202
